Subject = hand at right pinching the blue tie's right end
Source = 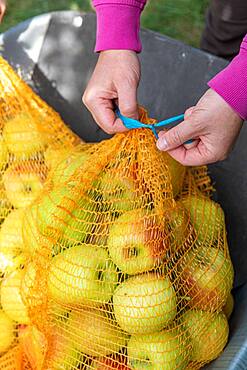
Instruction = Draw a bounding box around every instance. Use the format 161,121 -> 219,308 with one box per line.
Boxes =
157,89 -> 243,166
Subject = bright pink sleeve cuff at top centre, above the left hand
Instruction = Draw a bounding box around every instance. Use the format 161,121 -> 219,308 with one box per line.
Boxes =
93,0 -> 146,52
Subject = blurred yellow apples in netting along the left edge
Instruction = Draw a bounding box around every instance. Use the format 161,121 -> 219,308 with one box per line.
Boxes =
0,112 -> 81,357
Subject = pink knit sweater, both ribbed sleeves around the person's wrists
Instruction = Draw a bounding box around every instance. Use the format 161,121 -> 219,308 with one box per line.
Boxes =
93,0 -> 247,119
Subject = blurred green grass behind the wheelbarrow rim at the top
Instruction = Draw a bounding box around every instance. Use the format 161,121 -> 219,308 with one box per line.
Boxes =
0,0 -> 208,46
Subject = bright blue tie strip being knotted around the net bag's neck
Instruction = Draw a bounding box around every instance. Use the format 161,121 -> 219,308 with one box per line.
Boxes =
116,108 -> 193,144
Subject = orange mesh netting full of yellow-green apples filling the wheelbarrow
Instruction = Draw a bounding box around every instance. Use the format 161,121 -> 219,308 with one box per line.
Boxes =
0,55 -> 233,370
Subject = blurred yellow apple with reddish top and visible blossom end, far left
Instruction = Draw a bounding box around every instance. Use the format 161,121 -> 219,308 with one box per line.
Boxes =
3,160 -> 46,208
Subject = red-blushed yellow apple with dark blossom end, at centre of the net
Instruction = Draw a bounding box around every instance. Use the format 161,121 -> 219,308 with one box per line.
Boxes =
108,209 -> 168,275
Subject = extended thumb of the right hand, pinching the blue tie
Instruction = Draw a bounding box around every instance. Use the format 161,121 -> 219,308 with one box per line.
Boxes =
157,119 -> 198,151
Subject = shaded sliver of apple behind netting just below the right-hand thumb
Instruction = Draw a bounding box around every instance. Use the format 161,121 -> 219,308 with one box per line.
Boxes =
163,152 -> 186,198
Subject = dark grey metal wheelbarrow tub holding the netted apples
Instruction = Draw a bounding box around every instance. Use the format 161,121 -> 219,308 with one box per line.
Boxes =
0,11 -> 247,370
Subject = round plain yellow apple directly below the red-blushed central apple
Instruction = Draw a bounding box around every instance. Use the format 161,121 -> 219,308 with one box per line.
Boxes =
113,273 -> 177,334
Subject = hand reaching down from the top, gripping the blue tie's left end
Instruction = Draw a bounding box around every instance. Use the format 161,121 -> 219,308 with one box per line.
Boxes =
83,50 -> 141,134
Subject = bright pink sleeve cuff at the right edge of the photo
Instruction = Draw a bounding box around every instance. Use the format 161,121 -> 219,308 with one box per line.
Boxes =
208,35 -> 247,119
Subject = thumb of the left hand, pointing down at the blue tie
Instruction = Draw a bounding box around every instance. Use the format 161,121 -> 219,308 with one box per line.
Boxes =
118,86 -> 139,119
